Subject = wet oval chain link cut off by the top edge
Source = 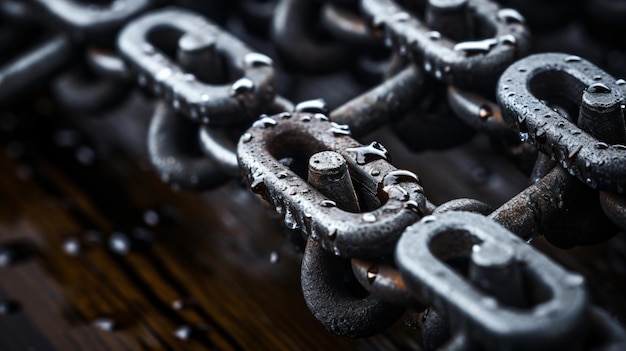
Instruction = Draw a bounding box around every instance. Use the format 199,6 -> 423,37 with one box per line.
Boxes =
361,0 -> 530,87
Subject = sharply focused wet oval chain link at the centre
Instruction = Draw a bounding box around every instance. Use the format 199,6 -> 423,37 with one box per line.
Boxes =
237,112 -> 426,257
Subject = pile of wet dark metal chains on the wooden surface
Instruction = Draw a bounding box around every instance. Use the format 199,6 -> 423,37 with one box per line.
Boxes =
0,0 -> 626,350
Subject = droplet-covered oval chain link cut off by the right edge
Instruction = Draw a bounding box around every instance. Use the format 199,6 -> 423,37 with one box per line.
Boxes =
497,53 -> 626,193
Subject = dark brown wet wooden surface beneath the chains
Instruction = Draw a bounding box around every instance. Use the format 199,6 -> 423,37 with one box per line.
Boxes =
0,80 -> 626,350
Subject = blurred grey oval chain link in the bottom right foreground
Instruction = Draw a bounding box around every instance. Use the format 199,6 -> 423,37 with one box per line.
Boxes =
395,212 -> 588,350
